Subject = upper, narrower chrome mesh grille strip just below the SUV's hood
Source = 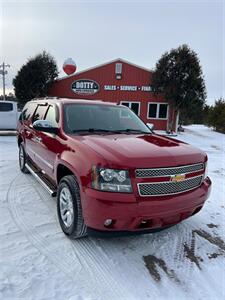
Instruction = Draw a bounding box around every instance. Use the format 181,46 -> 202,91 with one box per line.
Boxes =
135,163 -> 204,178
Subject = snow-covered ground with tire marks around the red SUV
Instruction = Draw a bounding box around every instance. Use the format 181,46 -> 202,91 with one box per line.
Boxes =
0,125 -> 225,300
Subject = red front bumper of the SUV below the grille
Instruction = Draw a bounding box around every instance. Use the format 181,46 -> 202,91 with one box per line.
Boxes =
82,177 -> 211,233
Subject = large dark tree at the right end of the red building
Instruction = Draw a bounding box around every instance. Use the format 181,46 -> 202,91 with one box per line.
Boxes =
151,45 -> 206,127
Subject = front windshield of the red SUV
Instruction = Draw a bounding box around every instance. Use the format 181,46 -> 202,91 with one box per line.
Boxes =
64,103 -> 151,133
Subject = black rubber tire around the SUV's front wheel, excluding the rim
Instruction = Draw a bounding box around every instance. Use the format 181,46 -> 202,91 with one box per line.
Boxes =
57,175 -> 87,239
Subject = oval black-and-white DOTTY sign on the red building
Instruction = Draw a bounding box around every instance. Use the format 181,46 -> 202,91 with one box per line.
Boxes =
71,79 -> 99,95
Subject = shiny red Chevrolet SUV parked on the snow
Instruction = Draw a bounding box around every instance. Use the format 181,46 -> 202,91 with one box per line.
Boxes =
17,98 -> 211,238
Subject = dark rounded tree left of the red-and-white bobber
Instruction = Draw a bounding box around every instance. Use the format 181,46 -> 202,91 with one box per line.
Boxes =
13,51 -> 58,103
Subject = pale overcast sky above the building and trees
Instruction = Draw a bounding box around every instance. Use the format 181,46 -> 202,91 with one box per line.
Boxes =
0,0 -> 225,104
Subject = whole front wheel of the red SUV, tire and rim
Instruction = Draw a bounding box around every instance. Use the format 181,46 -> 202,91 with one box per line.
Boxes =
57,175 -> 87,239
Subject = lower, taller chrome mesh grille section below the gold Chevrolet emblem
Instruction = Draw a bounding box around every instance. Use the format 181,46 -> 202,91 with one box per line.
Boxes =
138,176 -> 203,196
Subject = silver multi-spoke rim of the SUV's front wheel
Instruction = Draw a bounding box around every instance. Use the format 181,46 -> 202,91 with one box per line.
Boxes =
59,187 -> 74,228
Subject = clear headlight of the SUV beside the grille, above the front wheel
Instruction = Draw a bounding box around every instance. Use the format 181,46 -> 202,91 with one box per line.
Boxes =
92,167 -> 132,193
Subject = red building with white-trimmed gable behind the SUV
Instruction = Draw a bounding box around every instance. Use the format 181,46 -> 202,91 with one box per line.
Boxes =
49,59 -> 175,130
